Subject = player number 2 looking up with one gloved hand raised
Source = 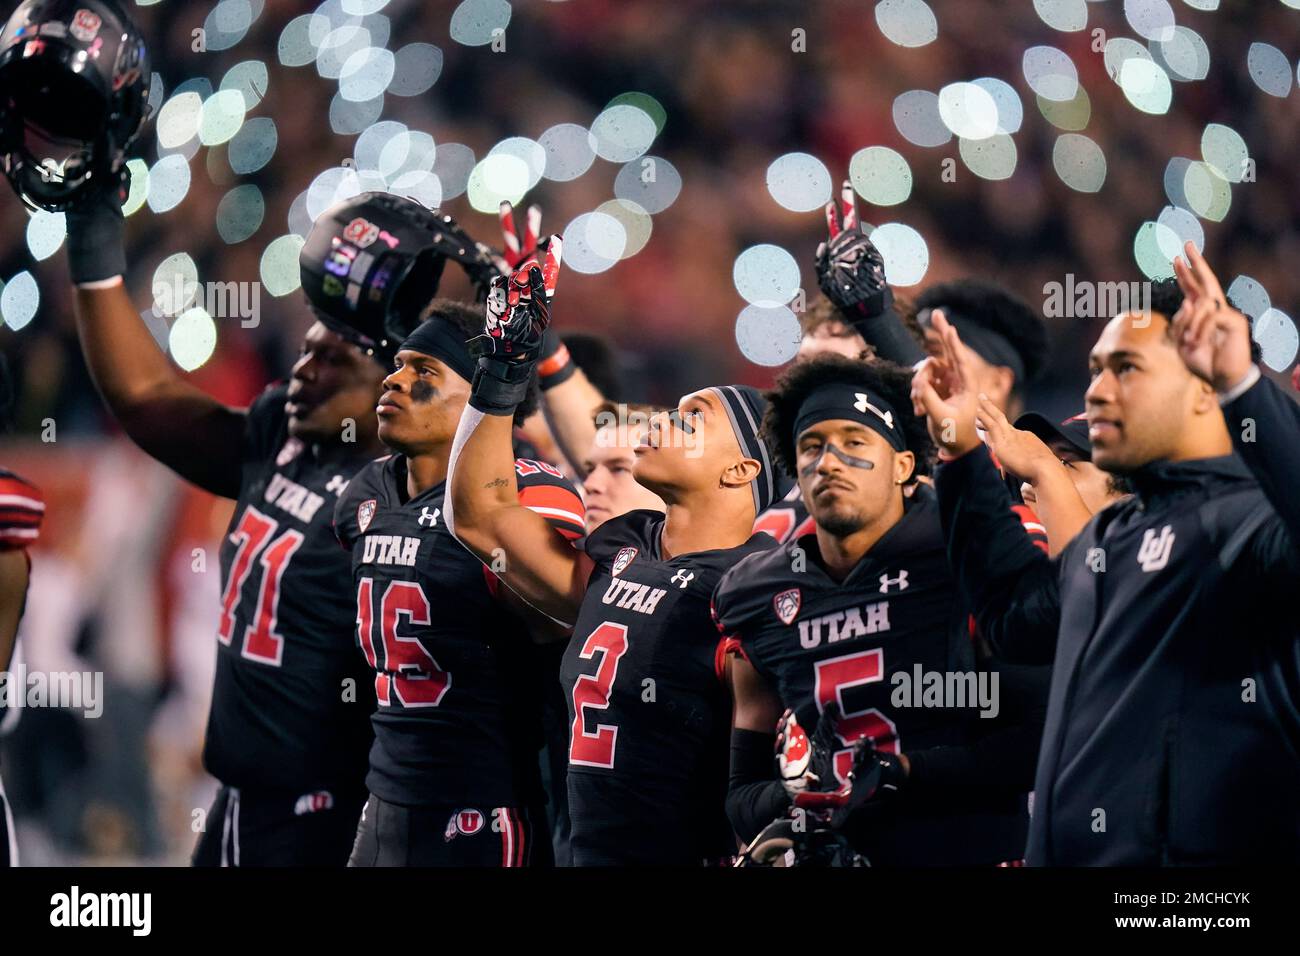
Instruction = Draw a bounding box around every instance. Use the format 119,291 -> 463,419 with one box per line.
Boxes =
450,247 -> 775,865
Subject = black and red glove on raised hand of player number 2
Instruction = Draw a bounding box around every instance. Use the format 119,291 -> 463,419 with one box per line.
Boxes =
469,235 -> 562,415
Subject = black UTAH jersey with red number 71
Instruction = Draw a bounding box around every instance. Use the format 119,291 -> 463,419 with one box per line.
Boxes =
203,385 -> 374,793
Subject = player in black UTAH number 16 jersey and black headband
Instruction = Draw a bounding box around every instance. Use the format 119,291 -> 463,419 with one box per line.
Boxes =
334,300 -> 585,866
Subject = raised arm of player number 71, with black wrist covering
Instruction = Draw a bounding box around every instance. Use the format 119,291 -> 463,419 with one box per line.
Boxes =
68,195 -> 246,498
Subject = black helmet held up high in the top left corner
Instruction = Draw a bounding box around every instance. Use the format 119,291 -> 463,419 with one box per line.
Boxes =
0,0 -> 150,212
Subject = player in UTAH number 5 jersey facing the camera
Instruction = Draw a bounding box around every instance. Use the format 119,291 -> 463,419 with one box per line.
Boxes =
714,355 -> 1043,865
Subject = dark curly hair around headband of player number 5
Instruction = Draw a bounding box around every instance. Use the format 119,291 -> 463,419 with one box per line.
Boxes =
762,354 -> 935,480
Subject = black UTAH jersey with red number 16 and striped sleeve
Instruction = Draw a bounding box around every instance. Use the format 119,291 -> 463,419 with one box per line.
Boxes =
334,455 -> 584,806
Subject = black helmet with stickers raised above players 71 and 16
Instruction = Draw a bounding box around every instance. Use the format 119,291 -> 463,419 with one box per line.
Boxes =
298,193 -> 498,360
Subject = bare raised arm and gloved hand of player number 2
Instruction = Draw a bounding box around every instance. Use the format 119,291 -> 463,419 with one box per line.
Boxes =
446,237 -> 590,624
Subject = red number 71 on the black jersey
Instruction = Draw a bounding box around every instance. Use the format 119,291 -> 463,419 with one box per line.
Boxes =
217,506 -> 303,667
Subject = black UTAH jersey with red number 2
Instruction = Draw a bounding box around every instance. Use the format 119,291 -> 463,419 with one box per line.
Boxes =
560,511 -> 775,866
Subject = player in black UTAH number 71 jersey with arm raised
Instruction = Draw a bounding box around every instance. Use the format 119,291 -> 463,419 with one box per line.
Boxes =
59,190 -> 488,866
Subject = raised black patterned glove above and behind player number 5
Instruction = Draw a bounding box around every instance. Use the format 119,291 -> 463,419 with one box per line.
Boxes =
816,181 -> 893,323
